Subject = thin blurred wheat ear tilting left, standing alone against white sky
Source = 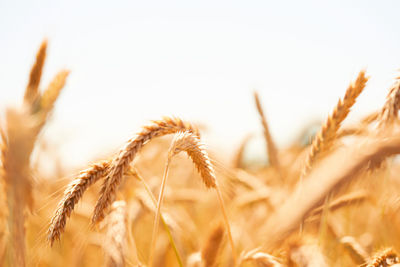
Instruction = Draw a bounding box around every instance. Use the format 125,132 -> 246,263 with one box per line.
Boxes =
254,91 -> 281,173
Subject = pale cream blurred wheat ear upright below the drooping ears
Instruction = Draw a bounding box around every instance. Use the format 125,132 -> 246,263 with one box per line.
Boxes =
103,201 -> 127,267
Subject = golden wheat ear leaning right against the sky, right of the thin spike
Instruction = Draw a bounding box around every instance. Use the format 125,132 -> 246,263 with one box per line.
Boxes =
301,71 -> 368,177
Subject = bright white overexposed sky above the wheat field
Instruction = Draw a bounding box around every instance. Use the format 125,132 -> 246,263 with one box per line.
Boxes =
0,0 -> 400,170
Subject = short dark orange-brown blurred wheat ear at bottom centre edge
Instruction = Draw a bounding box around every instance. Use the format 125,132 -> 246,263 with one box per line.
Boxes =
201,224 -> 225,267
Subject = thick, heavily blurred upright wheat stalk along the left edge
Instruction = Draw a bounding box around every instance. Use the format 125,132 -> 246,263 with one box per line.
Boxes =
1,109 -> 36,266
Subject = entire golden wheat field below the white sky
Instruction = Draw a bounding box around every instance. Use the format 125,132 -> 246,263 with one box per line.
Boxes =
0,41 -> 400,267
